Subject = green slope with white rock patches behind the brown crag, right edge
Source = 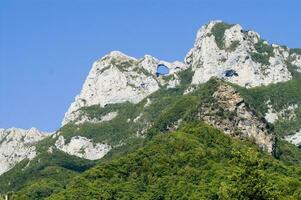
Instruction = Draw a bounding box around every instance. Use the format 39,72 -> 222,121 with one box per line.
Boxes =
233,64 -> 301,145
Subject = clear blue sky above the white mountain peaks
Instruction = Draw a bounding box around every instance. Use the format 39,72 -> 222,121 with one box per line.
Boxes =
0,0 -> 301,131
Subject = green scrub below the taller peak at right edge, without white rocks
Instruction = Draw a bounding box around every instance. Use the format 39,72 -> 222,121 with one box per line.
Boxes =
233,70 -> 301,136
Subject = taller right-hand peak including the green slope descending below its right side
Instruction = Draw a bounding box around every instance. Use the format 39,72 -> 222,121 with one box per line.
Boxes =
185,21 -> 301,146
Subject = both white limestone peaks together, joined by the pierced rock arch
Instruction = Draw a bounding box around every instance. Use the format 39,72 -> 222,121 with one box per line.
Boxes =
62,20 -> 301,125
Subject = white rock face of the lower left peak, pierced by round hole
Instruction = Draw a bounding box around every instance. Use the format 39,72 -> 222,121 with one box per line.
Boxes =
62,51 -> 187,125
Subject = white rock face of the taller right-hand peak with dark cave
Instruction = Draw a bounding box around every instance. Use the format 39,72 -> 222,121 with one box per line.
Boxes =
185,21 -> 292,87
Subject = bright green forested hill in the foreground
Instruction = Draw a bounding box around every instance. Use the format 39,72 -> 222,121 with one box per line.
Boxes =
42,123 -> 301,200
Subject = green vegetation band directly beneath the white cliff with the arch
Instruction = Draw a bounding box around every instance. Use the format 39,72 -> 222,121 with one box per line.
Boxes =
54,68 -> 192,146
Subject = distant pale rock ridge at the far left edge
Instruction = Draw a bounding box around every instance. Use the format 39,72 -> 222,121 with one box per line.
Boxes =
0,128 -> 49,175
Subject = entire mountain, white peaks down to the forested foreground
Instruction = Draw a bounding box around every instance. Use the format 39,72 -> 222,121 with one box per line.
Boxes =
0,21 -> 301,199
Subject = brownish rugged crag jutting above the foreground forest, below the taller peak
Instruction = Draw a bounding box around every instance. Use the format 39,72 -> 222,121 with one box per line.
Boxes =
198,83 -> 275,153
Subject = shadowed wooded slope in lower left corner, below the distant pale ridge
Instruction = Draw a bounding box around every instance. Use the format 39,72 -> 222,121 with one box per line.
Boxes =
0,151 -> 94,199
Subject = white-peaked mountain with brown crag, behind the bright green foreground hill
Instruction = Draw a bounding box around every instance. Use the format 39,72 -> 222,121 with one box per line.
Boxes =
0,21 -> 301,199
